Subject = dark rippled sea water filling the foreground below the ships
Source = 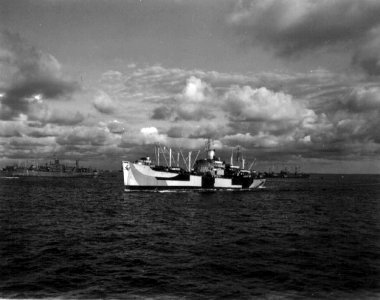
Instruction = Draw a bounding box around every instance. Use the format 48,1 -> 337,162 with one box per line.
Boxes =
0,173 -> 380,299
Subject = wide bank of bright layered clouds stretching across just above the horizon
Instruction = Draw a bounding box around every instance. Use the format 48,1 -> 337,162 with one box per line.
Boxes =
0,59 -> 380,169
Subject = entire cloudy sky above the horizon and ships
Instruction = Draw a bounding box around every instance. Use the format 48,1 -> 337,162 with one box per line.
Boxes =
0,0 -> 380,174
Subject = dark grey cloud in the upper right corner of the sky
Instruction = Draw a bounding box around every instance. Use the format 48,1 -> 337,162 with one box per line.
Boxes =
229,0 -> 380,56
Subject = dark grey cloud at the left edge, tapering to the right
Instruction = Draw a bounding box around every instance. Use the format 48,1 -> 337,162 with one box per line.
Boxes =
0,31 -> 79,120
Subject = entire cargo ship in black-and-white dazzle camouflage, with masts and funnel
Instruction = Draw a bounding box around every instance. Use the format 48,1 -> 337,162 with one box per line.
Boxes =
122,141 -> 265,191
